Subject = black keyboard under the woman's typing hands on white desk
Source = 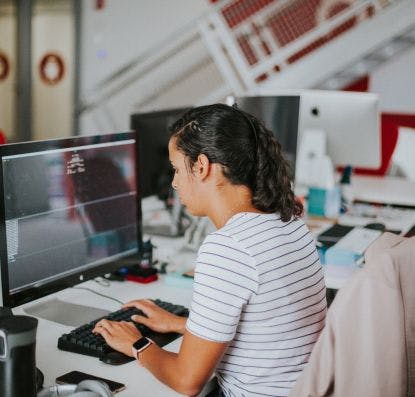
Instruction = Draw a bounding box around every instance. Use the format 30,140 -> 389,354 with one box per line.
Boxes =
58,299 -> 189,365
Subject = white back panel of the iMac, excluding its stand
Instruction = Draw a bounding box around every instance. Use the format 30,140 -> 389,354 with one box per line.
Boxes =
298,90 -> 381,168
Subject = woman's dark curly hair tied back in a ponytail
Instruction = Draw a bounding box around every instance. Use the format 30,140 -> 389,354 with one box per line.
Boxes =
170,104 -> 303,222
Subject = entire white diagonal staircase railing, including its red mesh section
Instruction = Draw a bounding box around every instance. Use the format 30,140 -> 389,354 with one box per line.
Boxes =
79,0 -> 415,125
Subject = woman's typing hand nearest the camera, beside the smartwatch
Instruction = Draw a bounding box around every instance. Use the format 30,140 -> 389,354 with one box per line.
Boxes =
92,320 -> 142,357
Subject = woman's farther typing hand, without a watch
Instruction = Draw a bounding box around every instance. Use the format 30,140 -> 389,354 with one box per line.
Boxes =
122,299 -> 186,334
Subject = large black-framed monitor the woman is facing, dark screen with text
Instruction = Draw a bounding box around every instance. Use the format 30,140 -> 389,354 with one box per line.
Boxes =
0,132 -> 141,307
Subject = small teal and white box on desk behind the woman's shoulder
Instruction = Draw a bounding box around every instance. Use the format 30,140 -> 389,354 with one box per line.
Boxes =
307,187 -> 340,218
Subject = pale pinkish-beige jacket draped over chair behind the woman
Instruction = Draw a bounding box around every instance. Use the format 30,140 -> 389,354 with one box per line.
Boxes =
290,233 -> 415,397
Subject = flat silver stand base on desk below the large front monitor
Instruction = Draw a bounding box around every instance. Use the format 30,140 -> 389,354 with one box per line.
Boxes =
23,298 -> 109,327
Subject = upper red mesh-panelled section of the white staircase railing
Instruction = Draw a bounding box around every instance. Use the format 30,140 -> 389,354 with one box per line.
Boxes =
204,0 -> 398,90
